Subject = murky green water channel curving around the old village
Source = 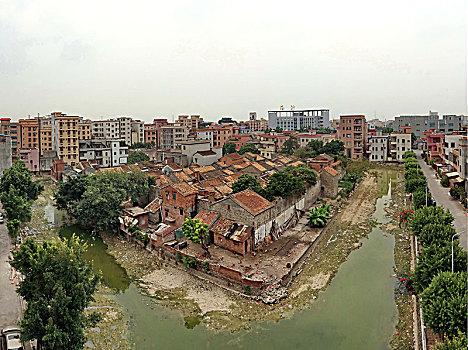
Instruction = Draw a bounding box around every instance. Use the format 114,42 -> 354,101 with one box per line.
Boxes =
54,176 -> 398,350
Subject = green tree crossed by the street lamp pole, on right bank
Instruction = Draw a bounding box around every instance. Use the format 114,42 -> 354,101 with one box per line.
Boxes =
411,241 -> 466,294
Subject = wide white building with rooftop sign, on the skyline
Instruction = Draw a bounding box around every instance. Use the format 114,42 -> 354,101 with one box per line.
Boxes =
268,109 -> 330,131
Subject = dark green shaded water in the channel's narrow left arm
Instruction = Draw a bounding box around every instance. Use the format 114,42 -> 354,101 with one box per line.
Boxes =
60,225 -> 130,292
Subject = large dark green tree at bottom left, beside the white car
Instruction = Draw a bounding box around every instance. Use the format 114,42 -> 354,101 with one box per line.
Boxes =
11,236 -> 100,350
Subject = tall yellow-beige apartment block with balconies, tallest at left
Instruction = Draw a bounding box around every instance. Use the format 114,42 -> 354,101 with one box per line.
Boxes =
50,112 -> 80,165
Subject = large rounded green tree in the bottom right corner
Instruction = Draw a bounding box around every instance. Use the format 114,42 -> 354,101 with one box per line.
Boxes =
421,272 -> 467,339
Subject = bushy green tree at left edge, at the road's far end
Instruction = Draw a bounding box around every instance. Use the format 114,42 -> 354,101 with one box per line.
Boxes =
0,160 -> 44,201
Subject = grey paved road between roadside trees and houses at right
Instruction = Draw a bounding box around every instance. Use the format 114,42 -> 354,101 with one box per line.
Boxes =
416,151 -> 468,251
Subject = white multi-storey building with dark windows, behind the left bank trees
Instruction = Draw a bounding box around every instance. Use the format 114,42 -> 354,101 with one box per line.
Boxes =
79,139 -> 128,168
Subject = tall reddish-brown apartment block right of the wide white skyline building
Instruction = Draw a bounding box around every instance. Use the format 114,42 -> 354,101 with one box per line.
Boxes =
338,115 -> 368,159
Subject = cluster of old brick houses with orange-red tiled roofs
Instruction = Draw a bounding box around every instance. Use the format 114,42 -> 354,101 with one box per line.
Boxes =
112,152 -> 340,255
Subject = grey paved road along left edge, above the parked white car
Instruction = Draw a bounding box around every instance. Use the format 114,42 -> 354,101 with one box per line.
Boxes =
0,204 -> 21,328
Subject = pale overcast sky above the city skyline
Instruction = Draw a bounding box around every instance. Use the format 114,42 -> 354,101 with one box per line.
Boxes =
0,0 -> 468,121
